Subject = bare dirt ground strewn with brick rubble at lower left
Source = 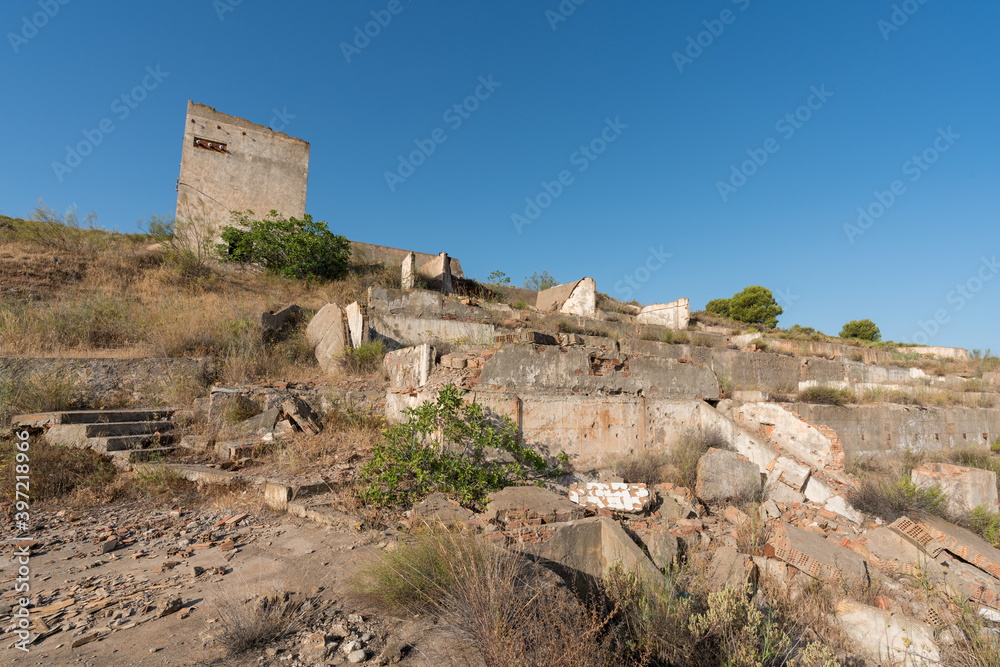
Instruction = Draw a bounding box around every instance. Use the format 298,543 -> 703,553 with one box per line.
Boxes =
0,503 -> 480,667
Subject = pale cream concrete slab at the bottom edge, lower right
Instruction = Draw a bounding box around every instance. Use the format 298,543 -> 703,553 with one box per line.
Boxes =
834,600 -> 941,667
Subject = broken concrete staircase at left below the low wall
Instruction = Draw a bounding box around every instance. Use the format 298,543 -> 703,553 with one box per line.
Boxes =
13,409 -> 180,467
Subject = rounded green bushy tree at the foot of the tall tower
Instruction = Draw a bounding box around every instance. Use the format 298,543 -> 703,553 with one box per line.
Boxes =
215,210 -> 351,279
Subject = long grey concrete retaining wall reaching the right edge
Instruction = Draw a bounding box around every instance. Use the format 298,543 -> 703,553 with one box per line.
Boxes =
782,403 -> 1000,457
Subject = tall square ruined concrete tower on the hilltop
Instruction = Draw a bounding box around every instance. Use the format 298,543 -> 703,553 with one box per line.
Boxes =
176,101 -> 309,244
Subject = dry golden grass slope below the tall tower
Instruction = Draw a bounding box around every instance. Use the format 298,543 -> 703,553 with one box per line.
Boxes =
0,219 -> 399,382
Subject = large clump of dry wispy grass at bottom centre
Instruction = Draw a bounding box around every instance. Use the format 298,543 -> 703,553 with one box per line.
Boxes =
356,529 -> 622,667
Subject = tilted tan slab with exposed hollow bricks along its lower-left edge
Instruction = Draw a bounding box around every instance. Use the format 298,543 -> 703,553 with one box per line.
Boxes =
764,523 -> 868,584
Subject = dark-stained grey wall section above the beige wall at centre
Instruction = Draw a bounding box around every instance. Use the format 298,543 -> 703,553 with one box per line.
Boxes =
479,345 -> 719,399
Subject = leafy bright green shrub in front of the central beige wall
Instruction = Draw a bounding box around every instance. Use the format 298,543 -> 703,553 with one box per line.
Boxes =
361,385 -> 565,506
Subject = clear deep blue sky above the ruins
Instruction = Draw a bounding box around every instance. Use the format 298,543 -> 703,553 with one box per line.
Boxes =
0,0 -> 1000,351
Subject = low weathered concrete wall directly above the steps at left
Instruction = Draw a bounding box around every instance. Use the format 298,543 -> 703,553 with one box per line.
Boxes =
0,357 -> 217,412
